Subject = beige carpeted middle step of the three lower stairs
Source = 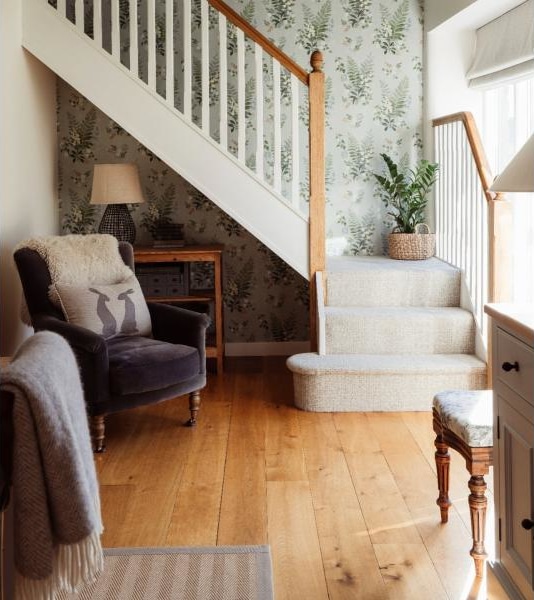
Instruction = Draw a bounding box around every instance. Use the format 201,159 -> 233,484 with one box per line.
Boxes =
325,306 -> 475,354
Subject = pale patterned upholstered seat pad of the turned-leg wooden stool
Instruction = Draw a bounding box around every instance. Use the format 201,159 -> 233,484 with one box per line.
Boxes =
433,390 -> 493,448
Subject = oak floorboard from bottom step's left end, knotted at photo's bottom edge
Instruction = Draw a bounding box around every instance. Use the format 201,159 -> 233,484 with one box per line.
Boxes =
298,412 -> 387,600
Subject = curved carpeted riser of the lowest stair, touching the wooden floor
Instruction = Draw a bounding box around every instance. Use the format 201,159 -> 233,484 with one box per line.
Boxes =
293,368 -> 486,412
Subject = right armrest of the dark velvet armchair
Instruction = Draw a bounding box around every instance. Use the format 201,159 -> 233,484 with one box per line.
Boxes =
148,302 -> 210,350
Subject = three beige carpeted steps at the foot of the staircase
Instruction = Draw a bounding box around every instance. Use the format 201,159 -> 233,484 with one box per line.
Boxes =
287,257 -> 486,412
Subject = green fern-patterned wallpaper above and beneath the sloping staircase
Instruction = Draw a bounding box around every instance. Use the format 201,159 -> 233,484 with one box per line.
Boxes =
58,0 -> 422,342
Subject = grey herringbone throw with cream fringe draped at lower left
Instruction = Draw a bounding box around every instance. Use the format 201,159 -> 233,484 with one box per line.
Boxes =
1,332 -> 103,600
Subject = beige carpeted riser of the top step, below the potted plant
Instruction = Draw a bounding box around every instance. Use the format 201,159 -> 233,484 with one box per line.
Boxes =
326,269 -> 460,307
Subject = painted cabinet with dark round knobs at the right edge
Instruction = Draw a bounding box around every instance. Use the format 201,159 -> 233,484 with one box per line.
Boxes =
486,304 -> 534,600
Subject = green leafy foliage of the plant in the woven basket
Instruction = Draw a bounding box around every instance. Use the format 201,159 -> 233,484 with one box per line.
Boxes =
373,154 -> 439,233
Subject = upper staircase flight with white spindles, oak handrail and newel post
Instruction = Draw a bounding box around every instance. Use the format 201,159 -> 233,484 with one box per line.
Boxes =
23,0 -> 324,279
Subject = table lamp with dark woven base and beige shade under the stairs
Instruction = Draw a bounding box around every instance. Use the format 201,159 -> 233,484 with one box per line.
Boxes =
91,163 -> 145,244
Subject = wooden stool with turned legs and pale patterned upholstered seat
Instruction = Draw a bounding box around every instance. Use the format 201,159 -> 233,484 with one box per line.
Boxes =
432,390 -> 493,577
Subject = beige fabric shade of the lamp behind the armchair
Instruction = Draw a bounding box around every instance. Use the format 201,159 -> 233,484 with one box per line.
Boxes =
91,163 -> 145,204
